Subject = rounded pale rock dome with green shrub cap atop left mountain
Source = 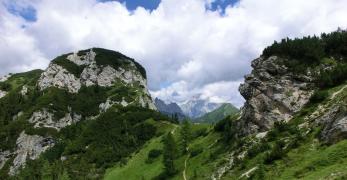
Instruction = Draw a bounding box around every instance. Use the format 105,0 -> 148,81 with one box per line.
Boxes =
38,48 -> 156,109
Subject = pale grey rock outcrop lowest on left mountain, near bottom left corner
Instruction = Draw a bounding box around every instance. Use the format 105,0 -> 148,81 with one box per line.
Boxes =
9,131 -> 54,175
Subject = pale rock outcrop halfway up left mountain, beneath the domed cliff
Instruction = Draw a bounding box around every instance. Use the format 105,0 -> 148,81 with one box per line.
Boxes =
29,109 -> 82,131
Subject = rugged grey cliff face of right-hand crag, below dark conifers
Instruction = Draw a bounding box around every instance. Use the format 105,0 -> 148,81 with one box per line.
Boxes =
239,56 -> 314,135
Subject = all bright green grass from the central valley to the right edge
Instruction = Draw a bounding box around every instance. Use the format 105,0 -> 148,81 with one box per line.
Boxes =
105,84 -> 347,180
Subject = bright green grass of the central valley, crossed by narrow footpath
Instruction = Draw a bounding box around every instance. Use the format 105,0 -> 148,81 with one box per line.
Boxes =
104,123 -> 222,180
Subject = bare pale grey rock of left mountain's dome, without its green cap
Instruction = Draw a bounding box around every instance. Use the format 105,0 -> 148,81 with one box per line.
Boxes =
38,49 -> 156,109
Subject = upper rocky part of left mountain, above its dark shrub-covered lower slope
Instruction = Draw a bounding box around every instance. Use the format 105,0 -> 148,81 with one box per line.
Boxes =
0,48 -> 166,176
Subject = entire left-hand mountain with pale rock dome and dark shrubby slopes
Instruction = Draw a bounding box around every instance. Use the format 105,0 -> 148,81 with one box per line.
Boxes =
0,48 -> 174,179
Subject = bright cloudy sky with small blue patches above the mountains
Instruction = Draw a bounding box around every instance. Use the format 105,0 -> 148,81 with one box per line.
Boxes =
0,0 -> 347,107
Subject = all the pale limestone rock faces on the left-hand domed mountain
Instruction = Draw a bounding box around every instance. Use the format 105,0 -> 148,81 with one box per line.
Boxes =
0,49 -> 156,175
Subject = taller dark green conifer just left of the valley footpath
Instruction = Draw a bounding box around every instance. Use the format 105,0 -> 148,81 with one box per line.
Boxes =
163,133 -> 177,176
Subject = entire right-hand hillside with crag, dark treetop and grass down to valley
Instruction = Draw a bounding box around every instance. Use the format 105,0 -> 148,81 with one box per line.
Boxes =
105,31 -> 347,180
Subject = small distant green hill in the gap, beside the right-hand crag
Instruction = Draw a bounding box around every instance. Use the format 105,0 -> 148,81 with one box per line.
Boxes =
194,103 -> 239,124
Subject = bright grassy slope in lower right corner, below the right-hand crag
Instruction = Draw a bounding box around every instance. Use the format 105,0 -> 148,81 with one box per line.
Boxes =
224,83 -> 347,179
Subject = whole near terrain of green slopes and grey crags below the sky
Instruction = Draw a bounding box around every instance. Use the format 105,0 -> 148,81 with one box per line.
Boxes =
0,31 -> 347,180
